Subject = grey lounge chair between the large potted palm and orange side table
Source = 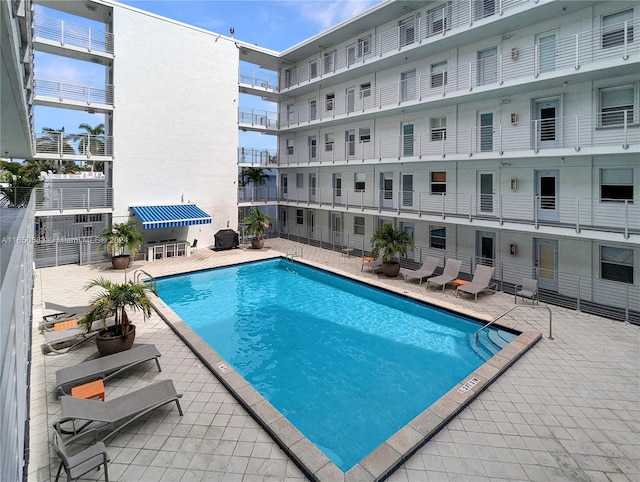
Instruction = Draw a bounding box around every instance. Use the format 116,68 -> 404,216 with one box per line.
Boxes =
56,345 -> 162,394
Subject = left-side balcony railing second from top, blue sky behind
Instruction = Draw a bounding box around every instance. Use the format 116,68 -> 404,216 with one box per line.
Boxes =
35,75 -> 114,111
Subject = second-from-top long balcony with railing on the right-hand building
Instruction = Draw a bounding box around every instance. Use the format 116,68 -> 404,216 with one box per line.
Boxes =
280,19 -> 640,128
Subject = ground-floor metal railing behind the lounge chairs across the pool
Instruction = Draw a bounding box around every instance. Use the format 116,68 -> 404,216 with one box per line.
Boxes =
273,226 -> 640,324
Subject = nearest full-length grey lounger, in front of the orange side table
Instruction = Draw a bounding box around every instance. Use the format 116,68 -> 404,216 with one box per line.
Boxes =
53,380 -> 183,443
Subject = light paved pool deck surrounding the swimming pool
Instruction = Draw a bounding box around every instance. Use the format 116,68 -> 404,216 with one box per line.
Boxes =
29,239 -> 640,482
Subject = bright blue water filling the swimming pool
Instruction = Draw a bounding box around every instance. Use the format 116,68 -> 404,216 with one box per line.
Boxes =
157,259 -> 516,472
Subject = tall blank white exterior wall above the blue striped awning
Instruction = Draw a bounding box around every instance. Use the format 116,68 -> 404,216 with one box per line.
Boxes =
113,6 -> 239,246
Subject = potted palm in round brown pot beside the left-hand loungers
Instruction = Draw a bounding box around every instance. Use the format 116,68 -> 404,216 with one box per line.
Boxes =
80,278 -> 153,356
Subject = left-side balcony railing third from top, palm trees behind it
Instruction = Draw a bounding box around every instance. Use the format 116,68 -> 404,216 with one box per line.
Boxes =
33,131 -> 113,158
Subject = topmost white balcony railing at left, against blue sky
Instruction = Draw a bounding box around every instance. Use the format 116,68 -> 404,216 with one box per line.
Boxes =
34,15 -> 114,54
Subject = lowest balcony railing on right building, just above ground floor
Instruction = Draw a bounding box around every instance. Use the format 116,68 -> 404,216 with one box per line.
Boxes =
238,186 -> 640,238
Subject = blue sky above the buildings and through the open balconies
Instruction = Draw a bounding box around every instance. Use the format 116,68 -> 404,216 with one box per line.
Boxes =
34,0 -> 381,148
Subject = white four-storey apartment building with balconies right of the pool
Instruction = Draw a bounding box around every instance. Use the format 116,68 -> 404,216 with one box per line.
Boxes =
241,0 -> 640,319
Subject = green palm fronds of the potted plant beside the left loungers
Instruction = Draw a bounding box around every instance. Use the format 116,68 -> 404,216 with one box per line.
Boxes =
79,277 -> 155,336
